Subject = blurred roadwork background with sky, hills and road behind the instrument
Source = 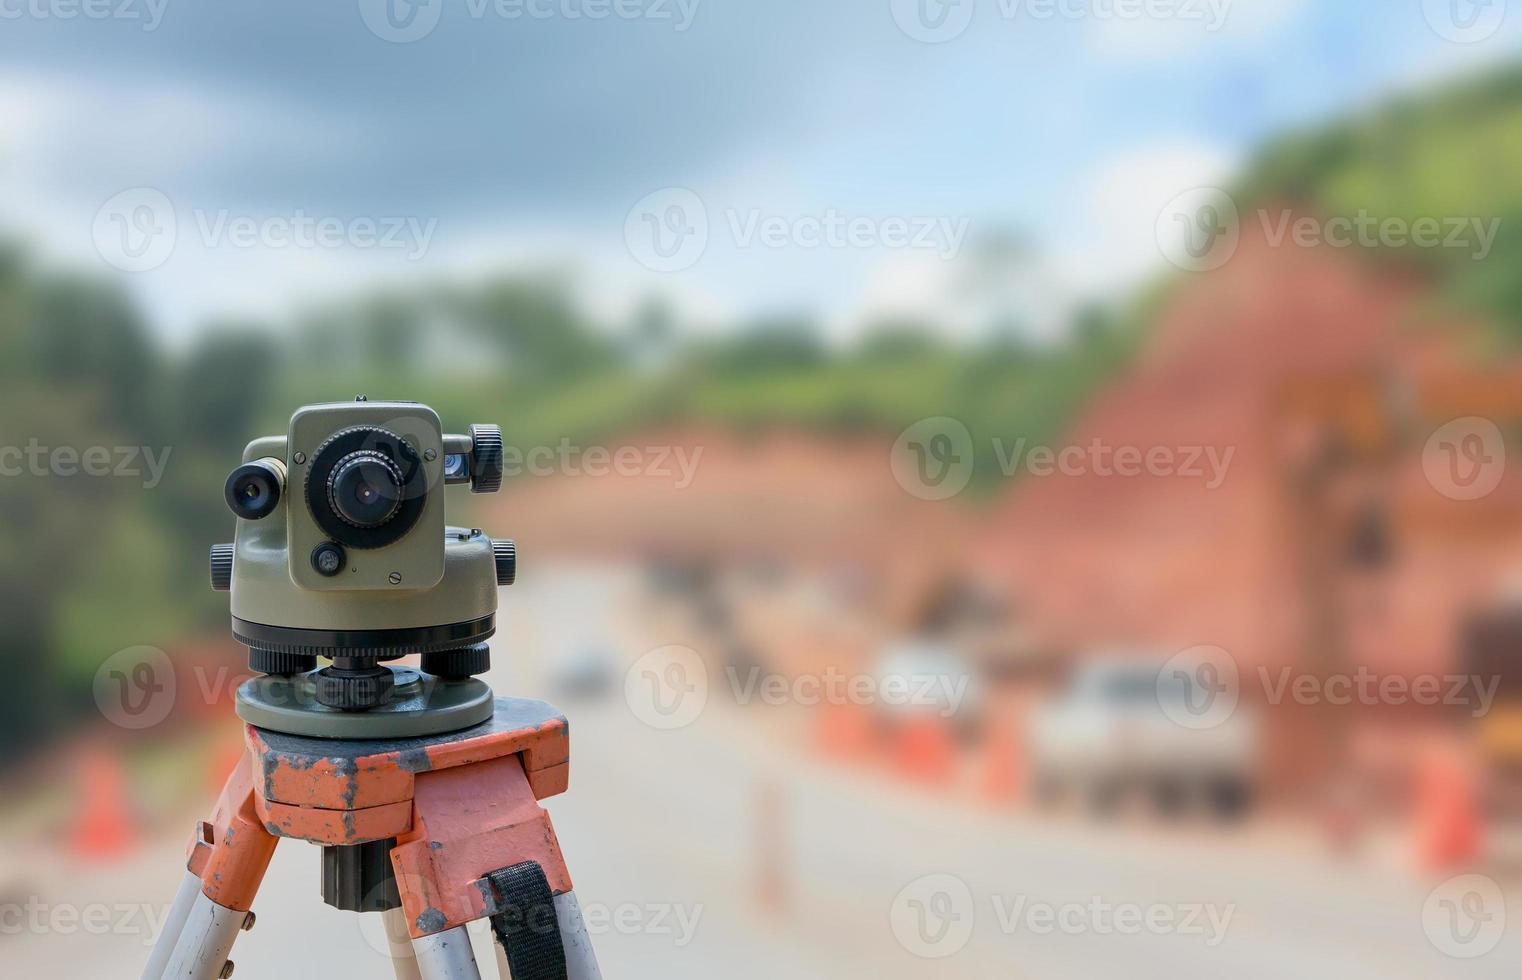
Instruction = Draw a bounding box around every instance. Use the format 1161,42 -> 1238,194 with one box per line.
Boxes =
0,0 -> 1522,980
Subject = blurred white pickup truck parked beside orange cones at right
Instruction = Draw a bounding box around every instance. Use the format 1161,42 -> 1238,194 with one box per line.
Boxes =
1027,656 -> 1259,819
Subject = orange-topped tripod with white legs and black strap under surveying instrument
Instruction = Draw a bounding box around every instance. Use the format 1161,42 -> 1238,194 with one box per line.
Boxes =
143,698 -> 601,980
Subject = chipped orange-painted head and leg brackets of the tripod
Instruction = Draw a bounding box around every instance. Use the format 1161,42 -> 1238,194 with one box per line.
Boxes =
189,702 -> 571,937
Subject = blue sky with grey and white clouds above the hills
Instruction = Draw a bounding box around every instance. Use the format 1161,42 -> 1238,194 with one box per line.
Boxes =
0,0 -> 1522,339
